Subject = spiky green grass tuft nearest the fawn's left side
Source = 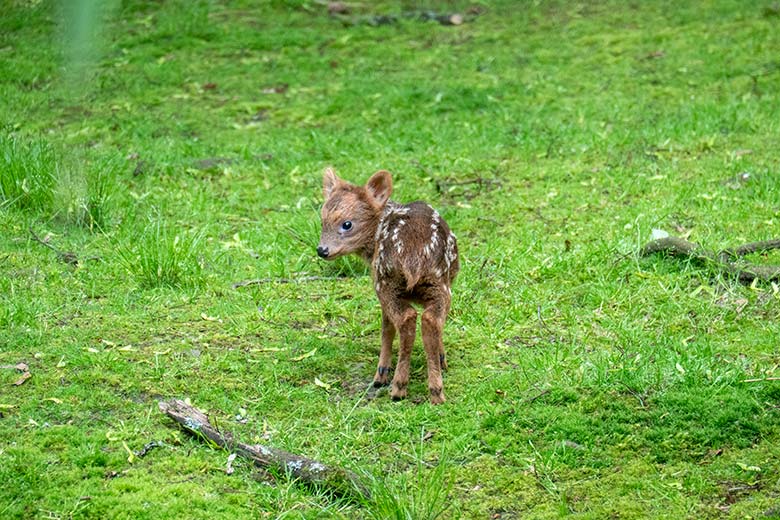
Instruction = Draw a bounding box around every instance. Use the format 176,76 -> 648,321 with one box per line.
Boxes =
119,217 -> 203,288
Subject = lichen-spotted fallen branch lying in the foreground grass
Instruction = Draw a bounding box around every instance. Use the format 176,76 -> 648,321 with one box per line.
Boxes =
159,399 -> 369,498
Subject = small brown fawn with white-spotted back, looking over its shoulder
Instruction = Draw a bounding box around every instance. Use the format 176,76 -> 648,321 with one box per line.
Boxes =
317,168 -> 460,404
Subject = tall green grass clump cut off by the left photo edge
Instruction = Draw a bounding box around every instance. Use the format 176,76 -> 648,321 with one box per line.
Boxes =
0,134 -> 57,210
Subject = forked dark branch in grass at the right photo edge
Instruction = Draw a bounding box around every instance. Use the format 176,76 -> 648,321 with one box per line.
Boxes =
640,237 -> 780,284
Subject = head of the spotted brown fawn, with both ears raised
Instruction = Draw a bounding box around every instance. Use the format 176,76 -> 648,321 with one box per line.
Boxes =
317,168 -> 393,260
